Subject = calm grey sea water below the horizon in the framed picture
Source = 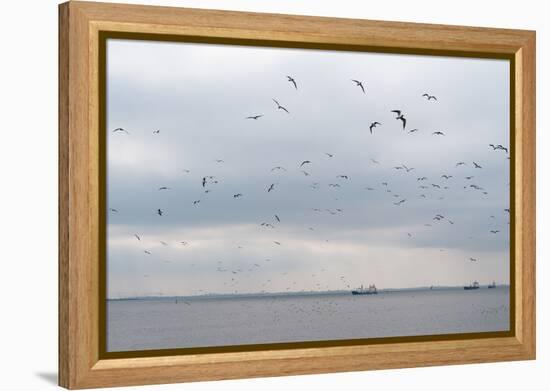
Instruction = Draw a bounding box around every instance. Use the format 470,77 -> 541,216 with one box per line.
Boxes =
107,287 -> 510,351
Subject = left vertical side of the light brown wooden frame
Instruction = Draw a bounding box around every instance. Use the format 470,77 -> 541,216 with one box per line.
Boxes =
59,3 -> 98,388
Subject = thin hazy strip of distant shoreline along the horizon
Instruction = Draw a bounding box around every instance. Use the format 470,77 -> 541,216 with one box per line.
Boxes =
107,284 -> 510,301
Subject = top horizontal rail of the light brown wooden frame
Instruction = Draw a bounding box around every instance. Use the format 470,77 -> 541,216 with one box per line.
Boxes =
73,2 -> 525,53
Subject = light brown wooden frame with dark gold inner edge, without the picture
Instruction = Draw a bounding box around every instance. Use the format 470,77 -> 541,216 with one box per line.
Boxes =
59,1 -> 535,389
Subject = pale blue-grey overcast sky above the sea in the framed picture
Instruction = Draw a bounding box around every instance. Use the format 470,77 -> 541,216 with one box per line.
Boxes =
106,39 -> 510,297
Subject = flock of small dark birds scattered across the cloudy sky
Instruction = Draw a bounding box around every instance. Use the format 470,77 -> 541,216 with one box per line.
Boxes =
109,76 -> 510,293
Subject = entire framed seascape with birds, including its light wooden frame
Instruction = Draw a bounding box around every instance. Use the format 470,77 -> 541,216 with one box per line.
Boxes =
59,2 -> 535,388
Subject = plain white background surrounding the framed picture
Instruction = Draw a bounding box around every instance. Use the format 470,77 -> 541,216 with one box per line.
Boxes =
0,0 -> 550,391
